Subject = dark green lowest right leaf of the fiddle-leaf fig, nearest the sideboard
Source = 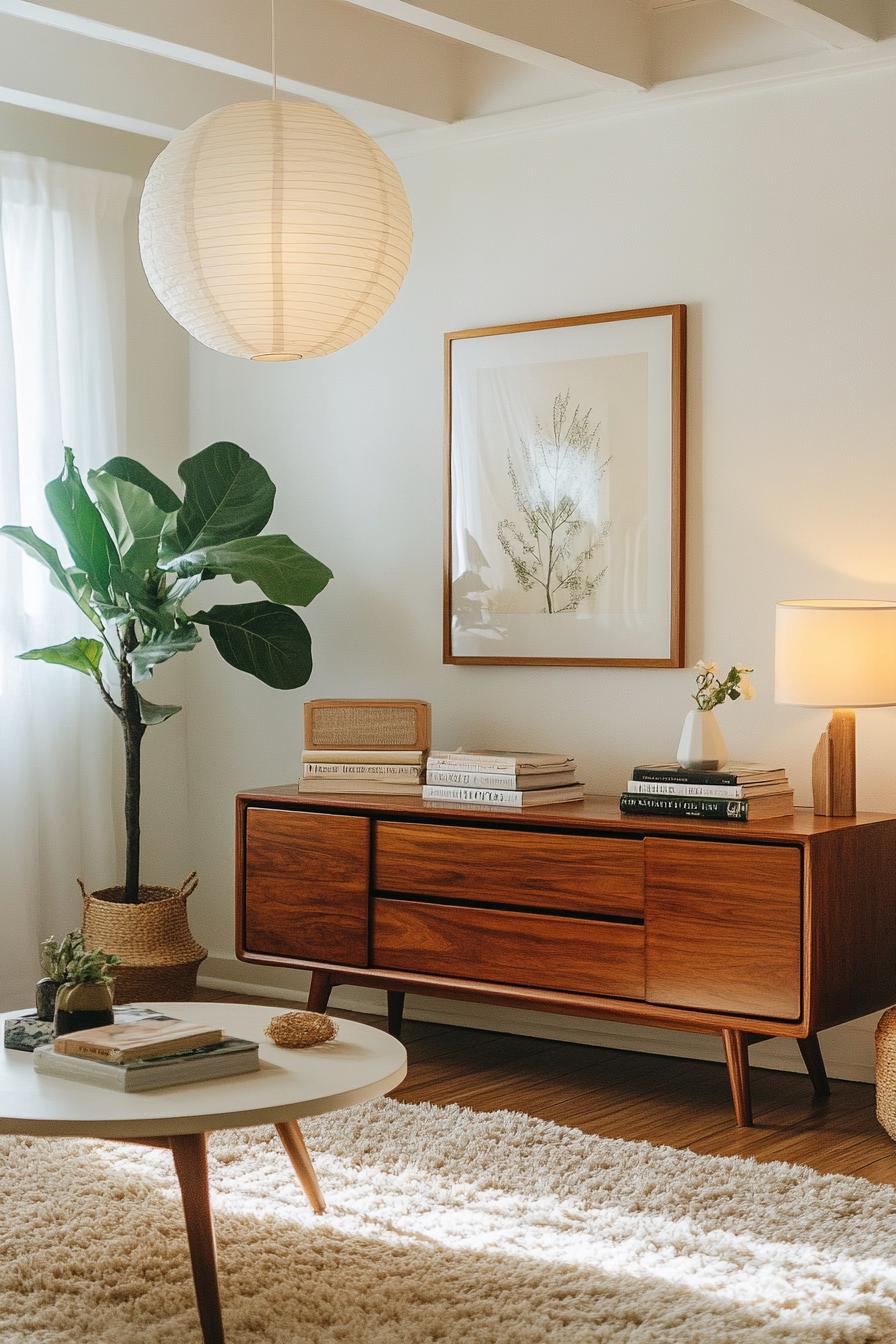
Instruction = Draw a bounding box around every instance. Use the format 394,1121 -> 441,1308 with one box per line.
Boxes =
192,602 -> 312,691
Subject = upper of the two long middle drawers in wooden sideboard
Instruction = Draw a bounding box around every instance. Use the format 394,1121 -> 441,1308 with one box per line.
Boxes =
373,821 -> 643,918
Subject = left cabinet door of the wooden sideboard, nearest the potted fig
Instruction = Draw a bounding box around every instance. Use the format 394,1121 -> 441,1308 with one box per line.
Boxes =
246,808 -> 371,966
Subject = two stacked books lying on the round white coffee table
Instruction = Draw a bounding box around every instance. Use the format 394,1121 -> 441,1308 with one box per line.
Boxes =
34,1013 -> 258,1091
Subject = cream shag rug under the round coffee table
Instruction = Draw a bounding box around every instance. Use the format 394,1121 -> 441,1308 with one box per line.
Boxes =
0,1101 -> 896,1344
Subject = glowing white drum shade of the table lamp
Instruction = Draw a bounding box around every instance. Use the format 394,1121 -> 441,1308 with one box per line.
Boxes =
775,598 -> 896,710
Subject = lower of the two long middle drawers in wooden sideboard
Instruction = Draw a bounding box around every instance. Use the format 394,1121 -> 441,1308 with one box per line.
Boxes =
372,896 -> 643,999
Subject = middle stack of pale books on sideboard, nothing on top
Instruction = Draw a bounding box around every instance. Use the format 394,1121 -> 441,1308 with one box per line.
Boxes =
423,750 -> 584,808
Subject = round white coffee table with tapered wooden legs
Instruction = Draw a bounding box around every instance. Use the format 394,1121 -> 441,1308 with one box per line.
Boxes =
0,1003 -> 407,1344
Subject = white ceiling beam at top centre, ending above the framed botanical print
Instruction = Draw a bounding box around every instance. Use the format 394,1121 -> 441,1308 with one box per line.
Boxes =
339,0 -> 650,93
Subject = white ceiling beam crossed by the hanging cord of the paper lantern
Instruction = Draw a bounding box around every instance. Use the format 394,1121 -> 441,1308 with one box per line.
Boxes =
0,0 -> 461,128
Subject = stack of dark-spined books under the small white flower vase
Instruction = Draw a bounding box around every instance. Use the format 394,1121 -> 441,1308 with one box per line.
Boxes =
619,761 -> 794,821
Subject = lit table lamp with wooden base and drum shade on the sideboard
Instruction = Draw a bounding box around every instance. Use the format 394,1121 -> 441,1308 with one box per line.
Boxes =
775,598 -> 896,817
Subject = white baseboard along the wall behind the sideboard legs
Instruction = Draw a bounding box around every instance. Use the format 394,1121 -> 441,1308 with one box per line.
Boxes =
199,957 -> 877,1083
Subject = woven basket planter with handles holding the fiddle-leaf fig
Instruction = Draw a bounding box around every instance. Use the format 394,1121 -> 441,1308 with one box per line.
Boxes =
78,872 -> 208,1004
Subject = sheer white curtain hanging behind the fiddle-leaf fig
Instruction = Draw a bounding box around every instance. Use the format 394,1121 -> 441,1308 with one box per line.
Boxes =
0,153 -> 136,1008
